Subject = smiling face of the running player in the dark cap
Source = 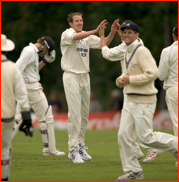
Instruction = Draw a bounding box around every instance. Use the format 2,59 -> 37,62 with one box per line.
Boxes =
123,28 -> 139,45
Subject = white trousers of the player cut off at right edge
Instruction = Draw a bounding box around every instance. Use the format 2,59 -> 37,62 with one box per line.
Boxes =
166,86 -> 178,136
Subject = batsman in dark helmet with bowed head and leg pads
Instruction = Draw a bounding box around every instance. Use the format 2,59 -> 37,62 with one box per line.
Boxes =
12,37 -> 65,156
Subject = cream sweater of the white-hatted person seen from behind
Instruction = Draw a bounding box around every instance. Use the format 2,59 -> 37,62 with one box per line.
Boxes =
1,54 -> 30,127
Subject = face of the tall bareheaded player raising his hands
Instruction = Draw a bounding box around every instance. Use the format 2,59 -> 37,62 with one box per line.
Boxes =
69,15 -> 83,32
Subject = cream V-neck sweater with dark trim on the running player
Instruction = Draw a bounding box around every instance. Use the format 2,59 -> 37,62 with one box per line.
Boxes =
124,40 -> 158,104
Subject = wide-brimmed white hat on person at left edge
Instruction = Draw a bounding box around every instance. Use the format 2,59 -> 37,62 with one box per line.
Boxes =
1,34 -> 15,51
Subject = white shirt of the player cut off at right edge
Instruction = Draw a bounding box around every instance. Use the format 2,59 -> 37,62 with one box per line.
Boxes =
159,41 -> 178,90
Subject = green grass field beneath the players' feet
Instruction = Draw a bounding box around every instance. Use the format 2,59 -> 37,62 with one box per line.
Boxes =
10,130 -> 178,181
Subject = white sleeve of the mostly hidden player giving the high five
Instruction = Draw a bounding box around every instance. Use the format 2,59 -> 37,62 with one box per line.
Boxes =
102,43 -> 126,61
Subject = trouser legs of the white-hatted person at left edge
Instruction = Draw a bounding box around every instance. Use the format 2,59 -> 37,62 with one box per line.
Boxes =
1,121 -> 14,179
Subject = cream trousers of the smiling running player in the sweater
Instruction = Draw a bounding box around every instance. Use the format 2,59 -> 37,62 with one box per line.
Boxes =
118,101 -> 178,172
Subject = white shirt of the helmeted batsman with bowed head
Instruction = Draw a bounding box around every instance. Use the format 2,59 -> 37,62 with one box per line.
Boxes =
16,43 -> 40,83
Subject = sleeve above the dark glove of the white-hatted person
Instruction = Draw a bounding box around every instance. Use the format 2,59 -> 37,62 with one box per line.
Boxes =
14,67 -> 30,111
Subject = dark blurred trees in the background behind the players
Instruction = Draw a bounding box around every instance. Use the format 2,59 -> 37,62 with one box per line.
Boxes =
1,1 -> 178,112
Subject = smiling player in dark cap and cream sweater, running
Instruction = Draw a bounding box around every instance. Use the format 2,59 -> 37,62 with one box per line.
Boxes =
99,22 -> 178,181
